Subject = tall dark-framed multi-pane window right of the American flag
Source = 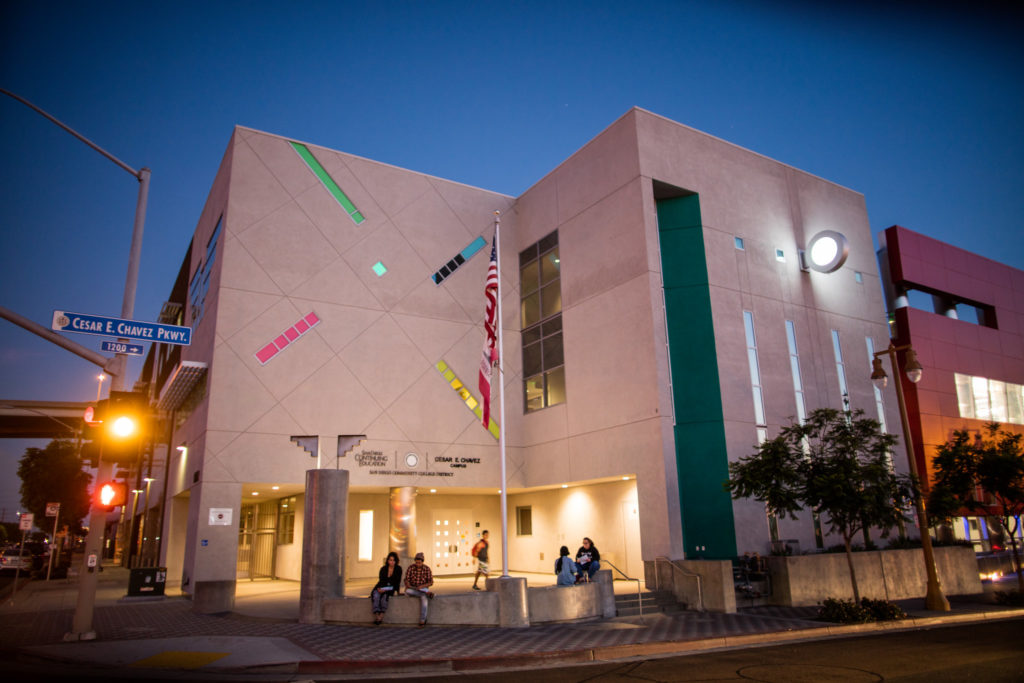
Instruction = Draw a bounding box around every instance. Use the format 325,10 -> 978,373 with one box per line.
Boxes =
519,230 -> 565,413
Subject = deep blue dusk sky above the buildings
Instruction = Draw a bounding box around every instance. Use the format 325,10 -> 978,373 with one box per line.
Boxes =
0,0 -> 1024,521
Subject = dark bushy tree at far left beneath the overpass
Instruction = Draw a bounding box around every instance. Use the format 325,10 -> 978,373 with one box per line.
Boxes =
17,439 -> 92,533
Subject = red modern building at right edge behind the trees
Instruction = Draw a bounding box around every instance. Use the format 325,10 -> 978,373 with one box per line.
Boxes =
879,225 -> 1024,552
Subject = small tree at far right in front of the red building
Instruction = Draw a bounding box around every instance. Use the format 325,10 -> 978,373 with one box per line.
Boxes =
928,422 -> 1024,593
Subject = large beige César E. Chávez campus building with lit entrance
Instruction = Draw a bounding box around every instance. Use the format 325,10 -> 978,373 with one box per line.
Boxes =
132,109 -> 899,605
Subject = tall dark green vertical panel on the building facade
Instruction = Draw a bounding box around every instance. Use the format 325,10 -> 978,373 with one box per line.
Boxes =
657,195 -> 736,558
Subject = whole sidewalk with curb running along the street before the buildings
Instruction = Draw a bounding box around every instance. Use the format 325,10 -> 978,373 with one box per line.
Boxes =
0,567 -> 1024,677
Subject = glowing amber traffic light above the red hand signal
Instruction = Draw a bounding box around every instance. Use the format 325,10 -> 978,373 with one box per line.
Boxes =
83,391 -> 148,465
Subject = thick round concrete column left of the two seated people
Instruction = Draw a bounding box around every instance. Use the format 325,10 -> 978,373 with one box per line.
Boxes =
299,470 -> 348,624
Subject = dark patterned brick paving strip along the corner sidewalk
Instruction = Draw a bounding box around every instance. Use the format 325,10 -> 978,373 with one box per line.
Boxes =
0,582 -> 1024,671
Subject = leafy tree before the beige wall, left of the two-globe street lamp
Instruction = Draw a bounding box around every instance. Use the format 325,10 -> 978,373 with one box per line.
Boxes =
725,409 -> 916,603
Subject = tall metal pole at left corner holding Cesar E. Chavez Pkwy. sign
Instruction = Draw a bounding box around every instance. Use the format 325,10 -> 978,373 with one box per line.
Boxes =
0,88 -> 150,640
